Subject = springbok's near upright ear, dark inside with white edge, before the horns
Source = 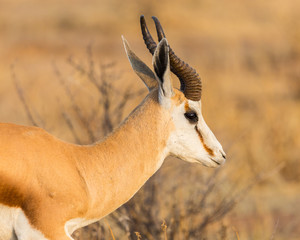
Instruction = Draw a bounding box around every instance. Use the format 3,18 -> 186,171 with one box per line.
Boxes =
152,38 -> 174,98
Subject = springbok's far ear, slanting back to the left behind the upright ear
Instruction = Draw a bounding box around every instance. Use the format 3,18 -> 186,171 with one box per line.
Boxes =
122,36 -> 158,92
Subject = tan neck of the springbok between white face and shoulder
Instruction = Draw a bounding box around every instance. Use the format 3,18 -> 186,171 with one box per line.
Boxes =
78,91 -> 172,218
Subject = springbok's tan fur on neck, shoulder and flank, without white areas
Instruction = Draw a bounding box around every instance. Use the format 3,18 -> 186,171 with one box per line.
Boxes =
0,90 -> 178,239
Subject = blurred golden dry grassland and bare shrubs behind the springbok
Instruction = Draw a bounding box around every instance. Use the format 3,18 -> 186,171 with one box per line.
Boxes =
0,0 -> 300,240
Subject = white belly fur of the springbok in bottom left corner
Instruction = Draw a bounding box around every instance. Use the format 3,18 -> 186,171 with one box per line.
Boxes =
0,204 -> 47,240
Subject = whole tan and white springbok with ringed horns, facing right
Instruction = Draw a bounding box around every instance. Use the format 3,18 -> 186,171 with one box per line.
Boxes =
0,16 -> 225,240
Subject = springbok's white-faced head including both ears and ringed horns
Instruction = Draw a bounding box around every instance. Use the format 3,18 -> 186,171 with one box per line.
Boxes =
123,16 -> 226,167
